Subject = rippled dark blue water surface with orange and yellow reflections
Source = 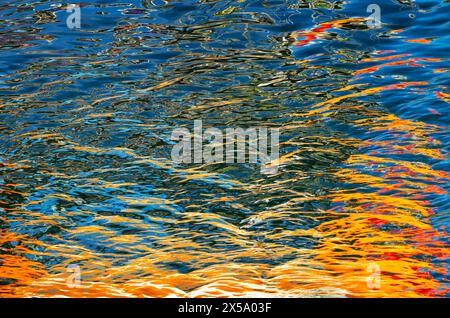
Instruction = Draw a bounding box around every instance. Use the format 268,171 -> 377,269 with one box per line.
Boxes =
0,0 -> 450,297
